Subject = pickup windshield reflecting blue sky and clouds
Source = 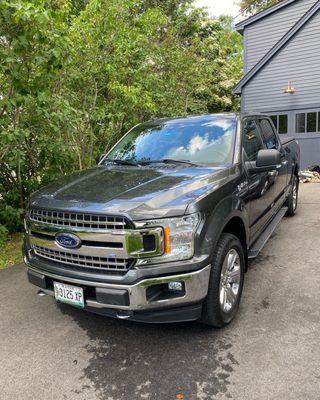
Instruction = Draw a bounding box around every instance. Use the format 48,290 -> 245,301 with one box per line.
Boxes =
107,115 -> 236,166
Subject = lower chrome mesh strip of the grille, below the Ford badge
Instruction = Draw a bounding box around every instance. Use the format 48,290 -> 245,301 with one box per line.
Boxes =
32,245 -> 133,273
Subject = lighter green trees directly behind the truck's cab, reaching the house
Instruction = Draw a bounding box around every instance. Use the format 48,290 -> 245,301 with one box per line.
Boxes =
64,0 -> 241,162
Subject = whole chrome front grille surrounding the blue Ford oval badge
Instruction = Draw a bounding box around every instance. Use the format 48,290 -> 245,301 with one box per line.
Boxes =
26,207 -> 164,274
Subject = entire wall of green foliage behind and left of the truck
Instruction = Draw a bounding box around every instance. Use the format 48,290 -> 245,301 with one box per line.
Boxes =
0,0 -> 242,231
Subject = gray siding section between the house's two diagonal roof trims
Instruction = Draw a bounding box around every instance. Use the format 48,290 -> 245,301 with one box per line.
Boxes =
244,0 -> 316,73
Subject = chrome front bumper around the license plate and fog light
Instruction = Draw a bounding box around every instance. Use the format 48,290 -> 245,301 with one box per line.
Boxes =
25,259 -> 211,311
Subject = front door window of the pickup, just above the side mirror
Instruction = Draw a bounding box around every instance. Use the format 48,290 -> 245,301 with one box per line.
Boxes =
242,119 -> 264,161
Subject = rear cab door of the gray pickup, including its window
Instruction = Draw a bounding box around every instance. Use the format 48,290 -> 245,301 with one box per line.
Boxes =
258,117 -> 288,211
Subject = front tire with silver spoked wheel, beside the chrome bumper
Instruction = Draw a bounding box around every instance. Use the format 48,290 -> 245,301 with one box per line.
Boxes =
202,233 -> 245,328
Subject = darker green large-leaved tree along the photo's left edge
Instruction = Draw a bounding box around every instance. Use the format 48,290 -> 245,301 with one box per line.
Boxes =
0,1 -> 74,223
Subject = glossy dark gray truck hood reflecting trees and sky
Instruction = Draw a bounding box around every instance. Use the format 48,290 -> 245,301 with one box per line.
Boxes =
30,165 -> 228,220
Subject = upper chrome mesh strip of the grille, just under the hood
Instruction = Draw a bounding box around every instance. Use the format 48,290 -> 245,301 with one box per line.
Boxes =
29,208 -> 131,230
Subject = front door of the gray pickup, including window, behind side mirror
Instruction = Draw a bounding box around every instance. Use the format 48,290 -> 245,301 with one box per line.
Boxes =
242,117 -> 273,241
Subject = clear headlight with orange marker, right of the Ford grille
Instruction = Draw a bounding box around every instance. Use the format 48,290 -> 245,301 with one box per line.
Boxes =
137,213 -> 201,265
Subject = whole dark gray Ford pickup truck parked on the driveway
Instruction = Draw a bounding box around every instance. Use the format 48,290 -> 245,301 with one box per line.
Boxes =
24,113 -> 300,327
